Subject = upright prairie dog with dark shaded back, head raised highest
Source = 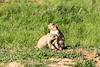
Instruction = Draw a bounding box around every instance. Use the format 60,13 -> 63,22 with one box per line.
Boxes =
48,23 -> 64,49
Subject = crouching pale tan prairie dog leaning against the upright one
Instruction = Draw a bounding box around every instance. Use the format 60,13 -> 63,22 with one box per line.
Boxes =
36,33 -> 57,49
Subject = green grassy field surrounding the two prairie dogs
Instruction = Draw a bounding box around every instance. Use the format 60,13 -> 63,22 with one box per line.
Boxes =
0,0 -> 100,67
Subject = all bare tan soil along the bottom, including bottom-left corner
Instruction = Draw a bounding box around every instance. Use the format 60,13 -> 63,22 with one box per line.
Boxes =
0,48 -> 100,67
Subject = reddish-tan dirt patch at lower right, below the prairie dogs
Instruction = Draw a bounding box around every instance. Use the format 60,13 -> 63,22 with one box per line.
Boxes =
47,48 -> 100,67
